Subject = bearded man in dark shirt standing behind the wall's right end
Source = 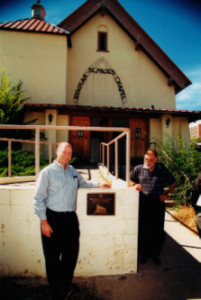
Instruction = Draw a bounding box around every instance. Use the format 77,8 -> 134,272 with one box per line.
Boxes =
131,150 -> 176,265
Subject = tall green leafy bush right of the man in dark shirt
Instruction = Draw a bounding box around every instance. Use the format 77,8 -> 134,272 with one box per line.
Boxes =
156,136 -> 201,204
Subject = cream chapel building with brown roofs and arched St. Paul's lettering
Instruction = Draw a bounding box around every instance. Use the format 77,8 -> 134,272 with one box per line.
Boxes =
0,0 -> 201,163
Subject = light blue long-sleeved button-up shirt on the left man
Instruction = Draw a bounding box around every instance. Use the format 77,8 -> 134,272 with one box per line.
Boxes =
34,161 -> 98,220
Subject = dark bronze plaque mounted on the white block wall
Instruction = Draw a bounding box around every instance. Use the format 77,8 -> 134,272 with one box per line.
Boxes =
87,193 -> 115,216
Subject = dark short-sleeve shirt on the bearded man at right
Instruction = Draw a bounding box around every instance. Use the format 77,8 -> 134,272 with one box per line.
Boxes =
131,163 -> 176,198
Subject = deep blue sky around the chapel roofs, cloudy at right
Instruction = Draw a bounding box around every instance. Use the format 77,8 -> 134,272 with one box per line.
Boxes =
0,0 -> 201,116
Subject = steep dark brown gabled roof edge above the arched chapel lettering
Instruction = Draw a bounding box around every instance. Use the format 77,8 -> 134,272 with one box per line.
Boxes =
58,0 -> 191,93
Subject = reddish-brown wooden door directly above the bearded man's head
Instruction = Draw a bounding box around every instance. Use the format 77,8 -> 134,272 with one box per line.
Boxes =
129,119 -> 146,157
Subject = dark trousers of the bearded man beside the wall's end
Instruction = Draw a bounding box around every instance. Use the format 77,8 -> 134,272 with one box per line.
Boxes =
138,195 -> 165,257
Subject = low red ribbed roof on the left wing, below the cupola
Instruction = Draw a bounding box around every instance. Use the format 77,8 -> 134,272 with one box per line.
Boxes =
0,18 -> 68,35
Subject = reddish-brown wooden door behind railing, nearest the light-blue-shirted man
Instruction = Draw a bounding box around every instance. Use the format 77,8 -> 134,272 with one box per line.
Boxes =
70,117 -> 90,161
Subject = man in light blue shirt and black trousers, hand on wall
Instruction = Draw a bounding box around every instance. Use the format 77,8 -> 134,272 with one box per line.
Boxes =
34,142 -> 110,300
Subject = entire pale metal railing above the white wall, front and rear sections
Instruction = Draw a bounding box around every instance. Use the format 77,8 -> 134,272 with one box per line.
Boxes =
0,125 -> 130,186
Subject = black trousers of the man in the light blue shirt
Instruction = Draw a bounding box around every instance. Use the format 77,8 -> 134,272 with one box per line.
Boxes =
42,209 -> 80,298
